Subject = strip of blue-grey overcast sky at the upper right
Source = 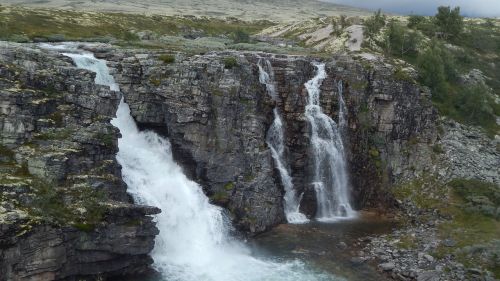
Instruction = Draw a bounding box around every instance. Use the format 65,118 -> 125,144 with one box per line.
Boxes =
323,0 -> 500,17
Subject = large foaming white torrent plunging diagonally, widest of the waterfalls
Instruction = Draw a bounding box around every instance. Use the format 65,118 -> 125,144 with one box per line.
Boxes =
60,47 -> 340,281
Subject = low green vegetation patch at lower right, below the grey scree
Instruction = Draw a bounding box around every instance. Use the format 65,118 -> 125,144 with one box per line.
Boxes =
393,175 -> 500,278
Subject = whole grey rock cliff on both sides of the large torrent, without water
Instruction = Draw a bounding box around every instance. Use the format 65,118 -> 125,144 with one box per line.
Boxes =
0,41 -> 437,280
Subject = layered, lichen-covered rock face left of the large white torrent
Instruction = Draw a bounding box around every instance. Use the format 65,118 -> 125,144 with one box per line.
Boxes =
0,43 -> 159,281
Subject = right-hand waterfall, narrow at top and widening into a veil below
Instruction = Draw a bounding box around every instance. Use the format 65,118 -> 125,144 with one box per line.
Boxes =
305,64 -> 356,221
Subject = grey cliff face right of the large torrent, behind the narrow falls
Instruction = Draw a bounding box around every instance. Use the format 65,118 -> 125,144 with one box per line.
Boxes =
108,49 -> 437,230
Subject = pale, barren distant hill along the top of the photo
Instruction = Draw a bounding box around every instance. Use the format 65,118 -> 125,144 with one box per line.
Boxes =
2,0 -> 369,21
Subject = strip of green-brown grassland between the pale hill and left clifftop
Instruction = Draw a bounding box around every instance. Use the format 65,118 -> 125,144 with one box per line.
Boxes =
0,7 -> 272,42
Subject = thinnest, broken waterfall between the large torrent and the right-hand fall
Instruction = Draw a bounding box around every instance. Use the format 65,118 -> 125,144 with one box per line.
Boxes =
257,59 -> 309,223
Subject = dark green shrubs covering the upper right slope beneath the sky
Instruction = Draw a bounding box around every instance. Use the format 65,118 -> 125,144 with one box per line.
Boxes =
364,7 -> 500,136
